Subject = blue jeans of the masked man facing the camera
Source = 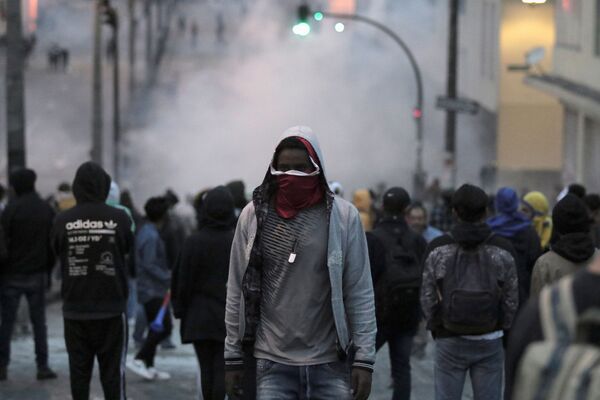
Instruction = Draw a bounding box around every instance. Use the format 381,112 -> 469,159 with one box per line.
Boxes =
256,359 -> 352,400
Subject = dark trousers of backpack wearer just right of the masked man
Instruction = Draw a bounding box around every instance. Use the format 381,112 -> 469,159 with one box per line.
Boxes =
375,329 -> 415,400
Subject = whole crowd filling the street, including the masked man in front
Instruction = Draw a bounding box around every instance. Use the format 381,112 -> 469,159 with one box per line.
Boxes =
0,127 -> 600,400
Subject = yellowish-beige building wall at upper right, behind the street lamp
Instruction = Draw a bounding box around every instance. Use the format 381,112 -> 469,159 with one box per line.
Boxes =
498,0 -> 563,178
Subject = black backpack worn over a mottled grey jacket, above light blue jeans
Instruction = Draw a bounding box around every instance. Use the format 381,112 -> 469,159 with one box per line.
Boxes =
437,235 -> 503,335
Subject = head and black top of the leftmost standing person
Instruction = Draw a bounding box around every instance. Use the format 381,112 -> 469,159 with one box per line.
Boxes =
1,169 -> 54,277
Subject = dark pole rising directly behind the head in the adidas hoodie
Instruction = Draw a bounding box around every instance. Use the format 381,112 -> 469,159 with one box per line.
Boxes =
90,0 -> 104,165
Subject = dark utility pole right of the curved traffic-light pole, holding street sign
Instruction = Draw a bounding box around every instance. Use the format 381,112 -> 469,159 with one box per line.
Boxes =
445,0 -> 459,188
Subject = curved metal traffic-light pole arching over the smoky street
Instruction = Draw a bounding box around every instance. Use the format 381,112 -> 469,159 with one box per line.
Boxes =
320,11 -> 425,198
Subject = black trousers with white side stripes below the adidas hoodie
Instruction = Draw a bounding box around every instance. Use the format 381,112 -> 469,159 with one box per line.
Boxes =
64,314 -> 127,400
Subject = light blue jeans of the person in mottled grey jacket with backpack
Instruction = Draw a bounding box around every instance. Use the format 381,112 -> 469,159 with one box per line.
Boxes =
434,337 -> 504,400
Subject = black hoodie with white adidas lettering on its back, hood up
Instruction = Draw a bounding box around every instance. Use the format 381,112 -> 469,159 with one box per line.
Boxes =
52,162 -> 133,320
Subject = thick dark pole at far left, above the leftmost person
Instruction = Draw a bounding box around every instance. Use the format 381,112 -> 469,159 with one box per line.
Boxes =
6,0 -> 25,175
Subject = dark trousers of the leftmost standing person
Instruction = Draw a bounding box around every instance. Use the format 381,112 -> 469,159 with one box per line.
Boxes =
0,273 -> 48,368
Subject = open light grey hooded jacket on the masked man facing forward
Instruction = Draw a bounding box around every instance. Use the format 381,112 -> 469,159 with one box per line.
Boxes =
225,126 -> 376,371
